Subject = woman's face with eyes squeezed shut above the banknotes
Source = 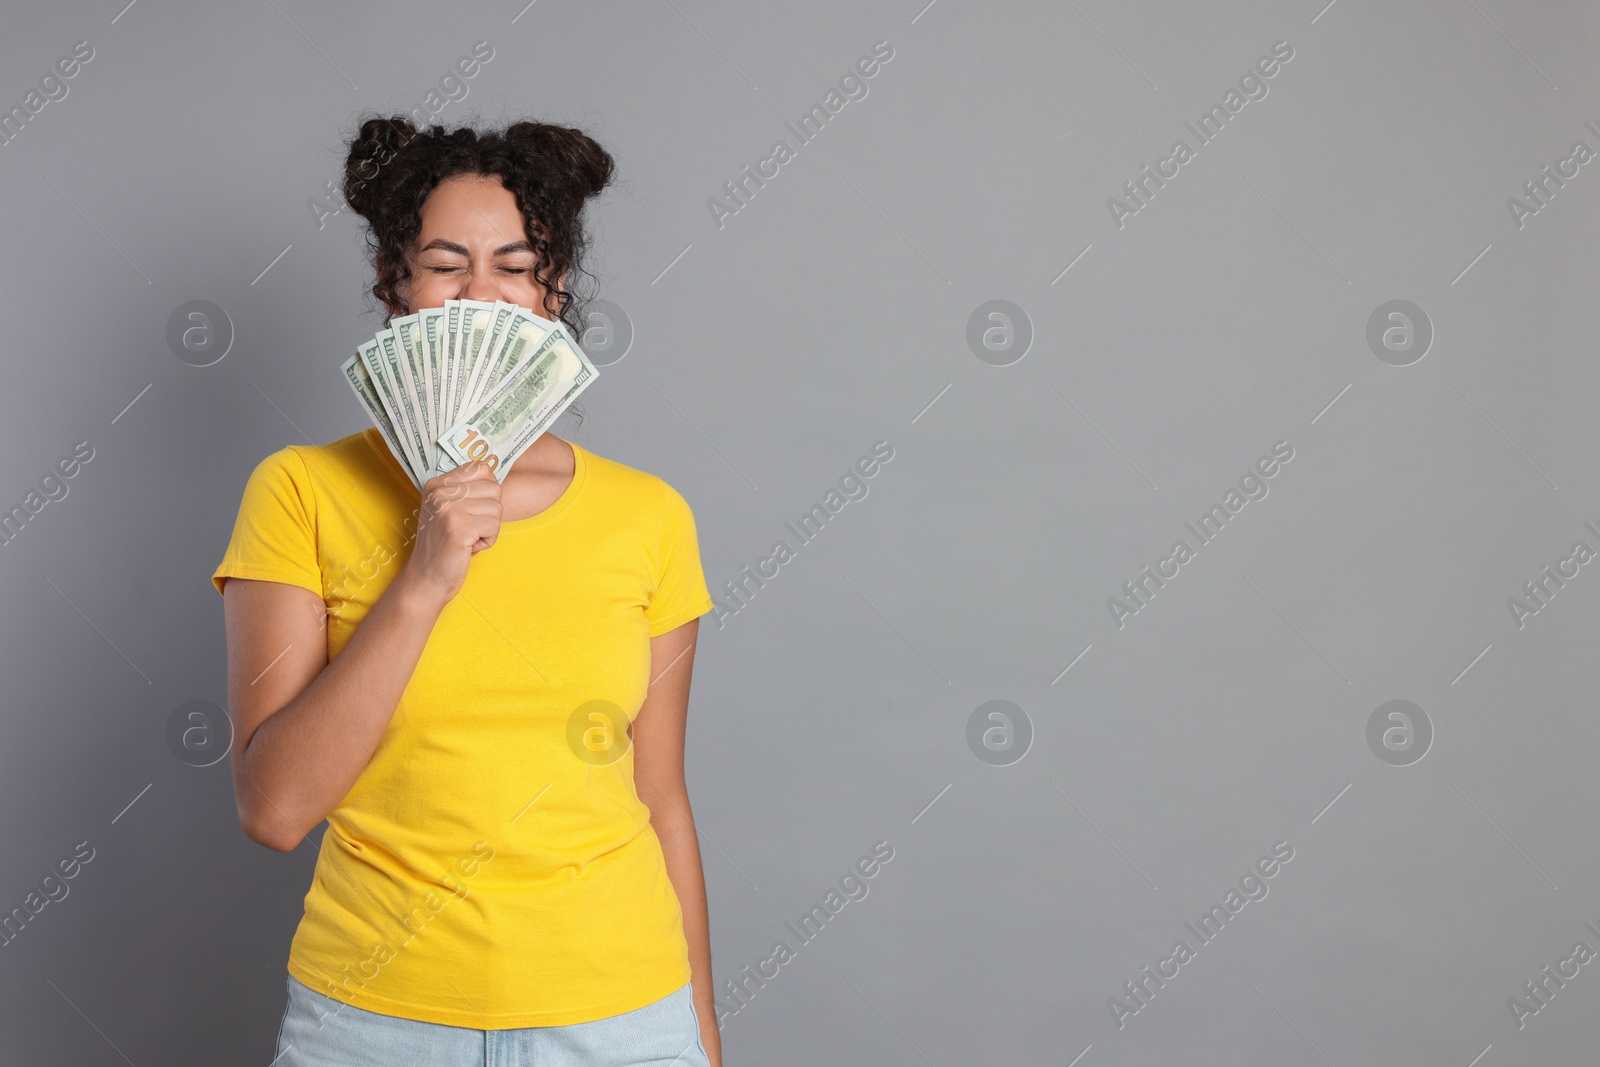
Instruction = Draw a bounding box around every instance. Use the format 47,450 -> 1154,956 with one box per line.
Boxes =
398,174 -> 550,318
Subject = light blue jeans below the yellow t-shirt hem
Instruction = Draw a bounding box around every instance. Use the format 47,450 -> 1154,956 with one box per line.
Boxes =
272,974 -> 710,1067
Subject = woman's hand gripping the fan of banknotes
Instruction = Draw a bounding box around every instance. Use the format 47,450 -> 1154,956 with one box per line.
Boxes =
395,461 -> 501,608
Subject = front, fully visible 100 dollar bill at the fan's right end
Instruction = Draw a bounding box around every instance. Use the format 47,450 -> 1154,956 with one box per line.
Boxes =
438,322 -> 600,483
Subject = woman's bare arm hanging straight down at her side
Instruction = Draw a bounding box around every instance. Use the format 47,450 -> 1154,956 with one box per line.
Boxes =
629,619 -> 722,1067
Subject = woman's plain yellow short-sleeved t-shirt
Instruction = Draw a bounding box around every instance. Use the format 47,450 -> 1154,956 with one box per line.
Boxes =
213,429 -> 712,1030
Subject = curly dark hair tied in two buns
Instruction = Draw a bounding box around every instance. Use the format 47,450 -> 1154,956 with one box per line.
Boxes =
344,115 -> 614,338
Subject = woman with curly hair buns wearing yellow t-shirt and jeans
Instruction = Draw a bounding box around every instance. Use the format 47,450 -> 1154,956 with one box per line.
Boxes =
213,118 -> 722,1067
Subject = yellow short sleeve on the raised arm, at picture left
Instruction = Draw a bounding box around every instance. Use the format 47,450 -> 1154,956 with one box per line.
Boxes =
211,448 -> 326,597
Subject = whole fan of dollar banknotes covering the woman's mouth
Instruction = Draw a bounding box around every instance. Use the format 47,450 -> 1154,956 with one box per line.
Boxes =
342,301 -> 598,488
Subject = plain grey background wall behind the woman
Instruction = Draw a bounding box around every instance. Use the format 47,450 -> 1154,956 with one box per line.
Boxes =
0,0 -> 1600,1067
